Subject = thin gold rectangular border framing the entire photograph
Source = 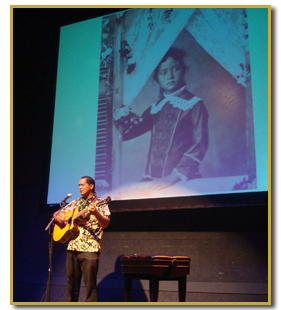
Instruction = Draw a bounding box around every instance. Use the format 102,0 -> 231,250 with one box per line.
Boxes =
10,5 -> 272,306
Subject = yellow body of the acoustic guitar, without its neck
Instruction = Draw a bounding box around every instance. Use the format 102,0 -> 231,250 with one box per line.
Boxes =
53,209 -> 79,243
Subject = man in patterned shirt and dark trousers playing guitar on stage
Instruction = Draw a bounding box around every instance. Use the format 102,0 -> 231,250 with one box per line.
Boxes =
54,176 -> 110,302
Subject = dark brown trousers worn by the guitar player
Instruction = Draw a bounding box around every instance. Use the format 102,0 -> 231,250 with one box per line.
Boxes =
66,251 -> 99,301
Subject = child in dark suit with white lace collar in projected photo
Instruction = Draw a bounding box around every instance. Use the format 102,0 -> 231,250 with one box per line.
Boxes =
114,48 -> 208,191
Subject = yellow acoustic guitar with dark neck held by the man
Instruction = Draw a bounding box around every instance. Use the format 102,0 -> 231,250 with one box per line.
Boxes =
53,196 -> 111,243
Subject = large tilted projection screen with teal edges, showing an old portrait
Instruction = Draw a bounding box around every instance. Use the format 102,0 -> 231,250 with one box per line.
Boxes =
47,8 -> 268,205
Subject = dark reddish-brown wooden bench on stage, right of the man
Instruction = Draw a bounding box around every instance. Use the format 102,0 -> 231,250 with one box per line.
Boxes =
121,254 -> 191,302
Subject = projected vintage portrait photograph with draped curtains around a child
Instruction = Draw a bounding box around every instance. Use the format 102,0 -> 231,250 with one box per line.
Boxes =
95,8 -> 257,200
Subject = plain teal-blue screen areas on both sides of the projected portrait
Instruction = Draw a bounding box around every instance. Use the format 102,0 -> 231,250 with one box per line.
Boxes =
47,8 -> 268,204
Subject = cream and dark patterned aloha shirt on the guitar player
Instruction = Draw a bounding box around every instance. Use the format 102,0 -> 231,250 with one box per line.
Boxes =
62,195 -> 110,252
